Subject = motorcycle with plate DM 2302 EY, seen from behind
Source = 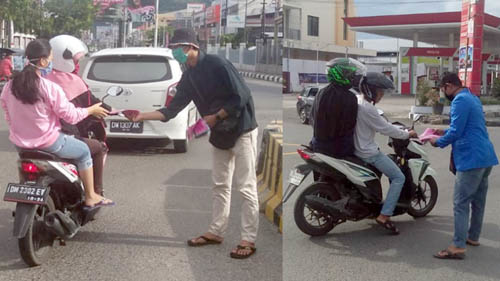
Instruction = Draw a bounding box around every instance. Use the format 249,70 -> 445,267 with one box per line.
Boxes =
4,86 -> 127,266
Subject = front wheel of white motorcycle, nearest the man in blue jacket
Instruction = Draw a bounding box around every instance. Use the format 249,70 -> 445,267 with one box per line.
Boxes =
408,176 -> 438,218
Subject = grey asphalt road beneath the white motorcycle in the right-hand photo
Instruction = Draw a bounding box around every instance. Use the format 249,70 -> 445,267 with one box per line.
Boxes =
283,95 -> 500,281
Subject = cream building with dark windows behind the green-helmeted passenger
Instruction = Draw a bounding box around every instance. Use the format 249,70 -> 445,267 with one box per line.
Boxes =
283,0 -> 376,92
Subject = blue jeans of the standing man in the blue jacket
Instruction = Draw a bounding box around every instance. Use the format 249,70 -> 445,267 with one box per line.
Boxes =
453,167 -> 492,248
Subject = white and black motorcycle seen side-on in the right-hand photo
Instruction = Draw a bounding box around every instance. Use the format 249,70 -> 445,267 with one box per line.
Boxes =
283,117 -> 438,236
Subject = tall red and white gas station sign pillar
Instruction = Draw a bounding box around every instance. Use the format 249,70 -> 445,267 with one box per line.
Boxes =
458,0 -> 484,95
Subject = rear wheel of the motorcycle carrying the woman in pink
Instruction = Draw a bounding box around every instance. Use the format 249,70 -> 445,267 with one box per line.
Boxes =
18,196 -> 56,266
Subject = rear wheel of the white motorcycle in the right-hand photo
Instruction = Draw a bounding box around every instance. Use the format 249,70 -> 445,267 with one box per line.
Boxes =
294,182 -> 341,236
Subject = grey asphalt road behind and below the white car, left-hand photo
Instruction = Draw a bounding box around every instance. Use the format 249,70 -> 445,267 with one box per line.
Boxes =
0,77 -> 282,281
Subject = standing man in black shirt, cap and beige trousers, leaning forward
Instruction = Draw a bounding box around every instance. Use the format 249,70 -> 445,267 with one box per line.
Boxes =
130,29 -> 259,258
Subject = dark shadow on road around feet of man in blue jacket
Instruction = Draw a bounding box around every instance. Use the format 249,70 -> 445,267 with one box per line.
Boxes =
310,216 -> 500,278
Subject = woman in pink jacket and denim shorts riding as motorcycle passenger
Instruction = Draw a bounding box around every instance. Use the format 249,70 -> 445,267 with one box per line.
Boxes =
0,39 -> 114,207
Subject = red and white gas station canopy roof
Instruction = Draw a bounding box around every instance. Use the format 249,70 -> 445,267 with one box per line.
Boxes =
344,12 -> 500,54
